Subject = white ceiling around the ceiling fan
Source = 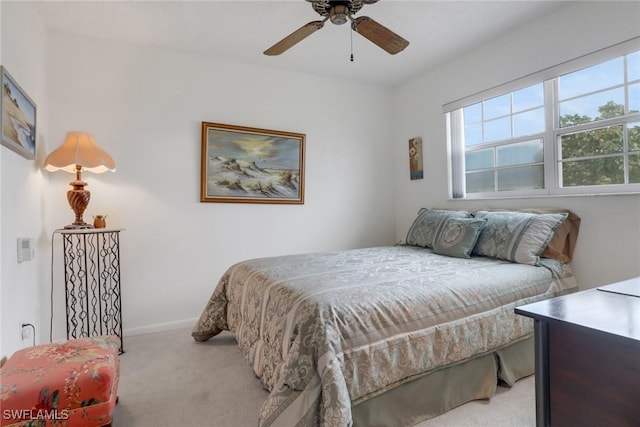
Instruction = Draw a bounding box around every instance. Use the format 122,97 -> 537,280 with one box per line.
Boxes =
33,0 -> 563,86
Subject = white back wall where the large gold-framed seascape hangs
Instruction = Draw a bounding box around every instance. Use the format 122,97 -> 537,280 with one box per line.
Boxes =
48,34 -> 395,342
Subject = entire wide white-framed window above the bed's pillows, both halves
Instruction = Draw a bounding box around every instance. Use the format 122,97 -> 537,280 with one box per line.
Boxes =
444,39 -> 640,198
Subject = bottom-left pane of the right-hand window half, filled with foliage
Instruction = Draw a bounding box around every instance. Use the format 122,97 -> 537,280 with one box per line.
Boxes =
562,156 -> 624,187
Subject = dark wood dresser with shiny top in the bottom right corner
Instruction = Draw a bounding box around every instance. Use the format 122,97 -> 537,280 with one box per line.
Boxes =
515,277 -> 640,427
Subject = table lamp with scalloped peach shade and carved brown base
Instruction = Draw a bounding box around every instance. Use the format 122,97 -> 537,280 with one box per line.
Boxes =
44,132 -> 116,228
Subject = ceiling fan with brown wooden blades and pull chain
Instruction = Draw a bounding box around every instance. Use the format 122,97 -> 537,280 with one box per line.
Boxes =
264,0 -> 409,56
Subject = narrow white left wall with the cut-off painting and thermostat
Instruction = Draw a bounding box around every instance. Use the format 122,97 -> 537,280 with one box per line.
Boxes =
0,2 -> 49,356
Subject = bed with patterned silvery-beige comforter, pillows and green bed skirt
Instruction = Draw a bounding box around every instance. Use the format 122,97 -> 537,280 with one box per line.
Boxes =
192,209 -> 579,427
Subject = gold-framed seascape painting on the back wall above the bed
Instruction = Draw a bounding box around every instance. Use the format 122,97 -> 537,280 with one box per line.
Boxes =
200,122 -> 305,204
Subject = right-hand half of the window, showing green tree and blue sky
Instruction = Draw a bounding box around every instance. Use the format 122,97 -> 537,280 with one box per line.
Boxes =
556,52 -> 640,187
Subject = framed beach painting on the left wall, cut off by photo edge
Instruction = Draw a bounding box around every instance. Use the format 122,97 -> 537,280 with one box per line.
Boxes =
0,67 -> 36,160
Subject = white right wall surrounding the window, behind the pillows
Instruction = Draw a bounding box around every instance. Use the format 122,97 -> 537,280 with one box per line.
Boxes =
393,2 -> 640,289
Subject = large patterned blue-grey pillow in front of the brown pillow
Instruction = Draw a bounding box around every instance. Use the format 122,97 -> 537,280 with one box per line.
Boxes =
473,211 -> 567,265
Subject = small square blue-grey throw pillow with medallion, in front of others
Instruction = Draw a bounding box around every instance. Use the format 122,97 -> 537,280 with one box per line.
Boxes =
433,217 -> 487,258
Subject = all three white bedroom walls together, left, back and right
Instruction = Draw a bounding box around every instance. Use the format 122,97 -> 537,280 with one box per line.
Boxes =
0,2 -> 640,355
